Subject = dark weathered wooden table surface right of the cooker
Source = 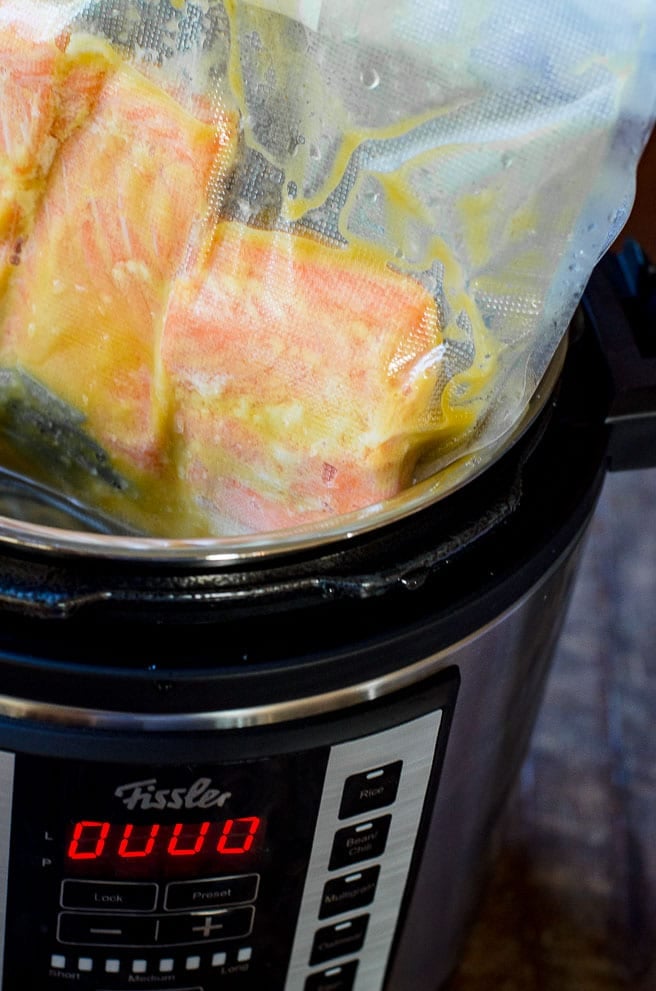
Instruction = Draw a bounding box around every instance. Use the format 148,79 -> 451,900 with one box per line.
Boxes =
450,470 -> 656,991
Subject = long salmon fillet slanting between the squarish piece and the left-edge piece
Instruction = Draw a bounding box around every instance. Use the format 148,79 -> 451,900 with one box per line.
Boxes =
0,38 -> 236,490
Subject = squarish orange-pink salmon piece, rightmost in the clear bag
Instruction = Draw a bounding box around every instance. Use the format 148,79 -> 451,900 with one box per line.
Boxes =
162,223 -> 442,534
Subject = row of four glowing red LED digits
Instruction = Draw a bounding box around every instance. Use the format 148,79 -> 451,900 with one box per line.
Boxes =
66,816 -> 262,867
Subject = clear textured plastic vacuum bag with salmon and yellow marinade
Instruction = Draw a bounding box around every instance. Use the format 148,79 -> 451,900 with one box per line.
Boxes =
0,0 -> 656,538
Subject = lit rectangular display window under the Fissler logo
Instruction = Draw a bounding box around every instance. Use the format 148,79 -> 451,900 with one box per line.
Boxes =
65,816 -> 264,877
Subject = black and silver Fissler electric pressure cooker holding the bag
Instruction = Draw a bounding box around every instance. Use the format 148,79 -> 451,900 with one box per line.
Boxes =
0,247 -> 656,991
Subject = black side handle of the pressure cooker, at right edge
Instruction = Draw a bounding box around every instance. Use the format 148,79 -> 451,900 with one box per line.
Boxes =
584,241 -> 656,471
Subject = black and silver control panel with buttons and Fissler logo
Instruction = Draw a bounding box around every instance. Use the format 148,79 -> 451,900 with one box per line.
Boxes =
0,676 -> 456,991
